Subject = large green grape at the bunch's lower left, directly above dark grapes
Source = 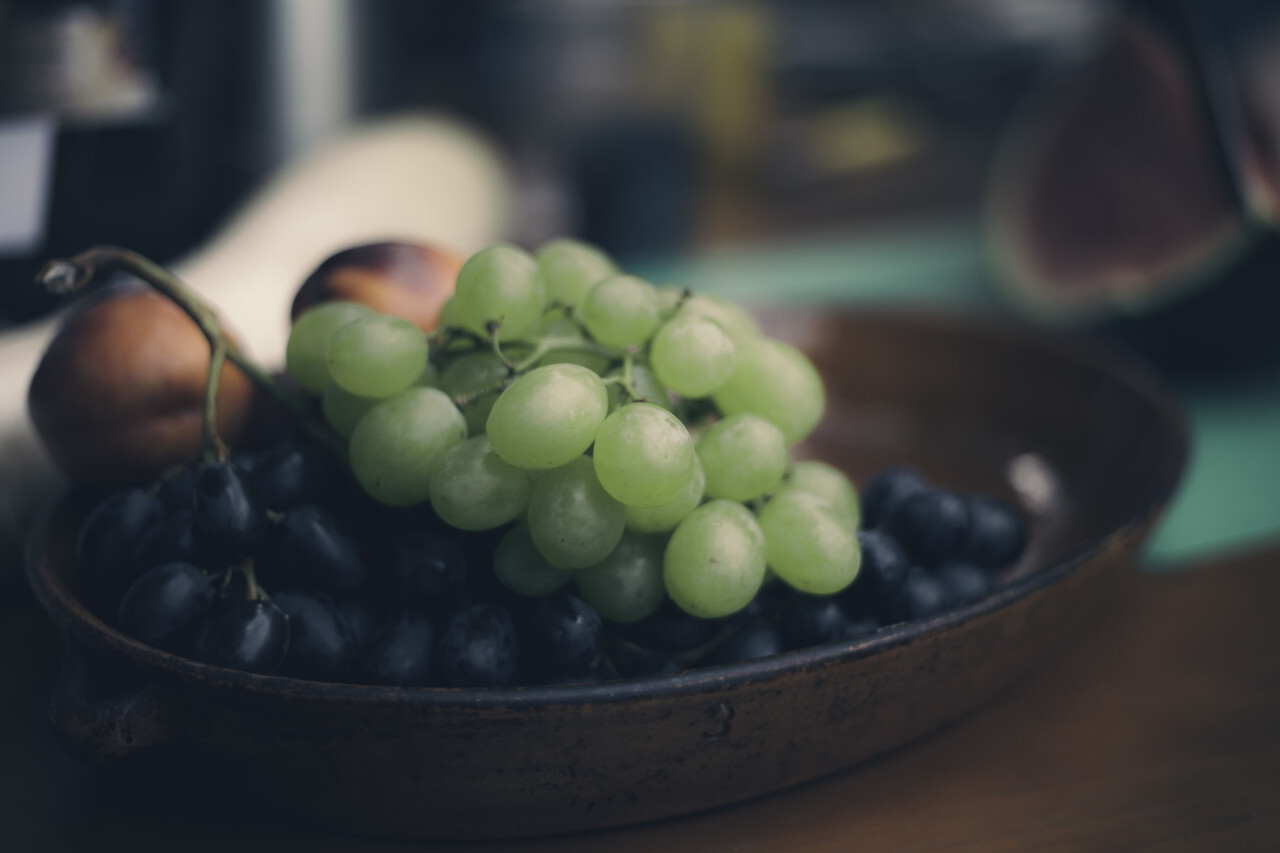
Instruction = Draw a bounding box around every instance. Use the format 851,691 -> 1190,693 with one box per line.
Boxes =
348,387 -> 467,506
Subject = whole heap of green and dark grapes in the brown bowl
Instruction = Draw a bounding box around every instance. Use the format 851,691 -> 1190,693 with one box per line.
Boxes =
81,240 -> 1025,686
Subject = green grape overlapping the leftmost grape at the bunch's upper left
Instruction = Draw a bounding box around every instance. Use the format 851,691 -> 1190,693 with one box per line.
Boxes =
325,314 -> 426,397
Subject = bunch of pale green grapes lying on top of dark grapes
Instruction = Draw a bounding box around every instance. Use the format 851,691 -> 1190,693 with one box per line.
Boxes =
287,240 -> 860,622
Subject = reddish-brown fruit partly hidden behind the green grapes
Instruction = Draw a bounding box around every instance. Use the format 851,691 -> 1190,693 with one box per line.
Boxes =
289,242 -> 466,332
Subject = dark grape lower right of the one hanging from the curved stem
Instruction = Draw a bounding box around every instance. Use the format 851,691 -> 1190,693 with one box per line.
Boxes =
273,505 -> 367,596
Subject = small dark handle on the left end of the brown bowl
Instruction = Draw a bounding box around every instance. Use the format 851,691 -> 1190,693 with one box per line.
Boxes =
49,640 -> 178,762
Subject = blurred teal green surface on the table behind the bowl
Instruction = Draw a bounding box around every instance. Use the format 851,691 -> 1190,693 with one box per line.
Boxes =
632,220 -> 1280,570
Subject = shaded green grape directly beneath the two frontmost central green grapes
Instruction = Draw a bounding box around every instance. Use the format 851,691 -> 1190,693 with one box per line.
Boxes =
529,456 -> 626,569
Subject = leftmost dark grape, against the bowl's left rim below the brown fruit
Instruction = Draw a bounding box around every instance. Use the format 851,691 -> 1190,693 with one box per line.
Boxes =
77,489 -> 164,592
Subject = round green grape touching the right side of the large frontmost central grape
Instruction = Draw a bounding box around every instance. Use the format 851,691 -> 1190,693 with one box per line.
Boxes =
591,403 -> 694,506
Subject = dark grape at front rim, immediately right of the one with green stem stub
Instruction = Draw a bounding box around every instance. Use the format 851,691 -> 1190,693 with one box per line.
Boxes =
271,589 -> 356,681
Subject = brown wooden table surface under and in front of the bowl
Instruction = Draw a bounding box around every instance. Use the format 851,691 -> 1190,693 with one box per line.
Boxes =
0,546 -> 1280,853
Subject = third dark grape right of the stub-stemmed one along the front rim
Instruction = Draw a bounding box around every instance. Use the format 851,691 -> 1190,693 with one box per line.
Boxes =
436,605 -> 520,686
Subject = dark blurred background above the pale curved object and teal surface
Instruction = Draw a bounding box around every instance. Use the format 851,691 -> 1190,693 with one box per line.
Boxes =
0,0 -> 1131,321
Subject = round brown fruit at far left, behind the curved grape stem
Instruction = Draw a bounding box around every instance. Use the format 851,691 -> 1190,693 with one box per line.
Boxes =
27,291 -> 256,491
